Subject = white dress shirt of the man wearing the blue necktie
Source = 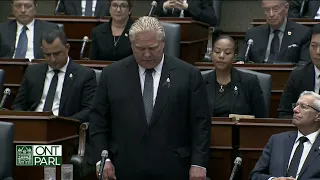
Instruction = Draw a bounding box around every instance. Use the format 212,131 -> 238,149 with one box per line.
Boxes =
12,20 -> 34,62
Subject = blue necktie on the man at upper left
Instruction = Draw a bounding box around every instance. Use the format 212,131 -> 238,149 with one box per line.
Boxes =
14,26 -> 28,59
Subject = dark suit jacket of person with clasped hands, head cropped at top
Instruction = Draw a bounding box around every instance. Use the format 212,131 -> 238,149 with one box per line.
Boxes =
154,0 -> 218,26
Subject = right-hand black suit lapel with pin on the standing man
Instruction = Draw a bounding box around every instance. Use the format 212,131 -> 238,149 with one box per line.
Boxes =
150,56 -> 175,127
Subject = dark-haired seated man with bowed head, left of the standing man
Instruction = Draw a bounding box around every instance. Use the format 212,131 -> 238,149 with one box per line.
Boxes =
12,29 -> 97,121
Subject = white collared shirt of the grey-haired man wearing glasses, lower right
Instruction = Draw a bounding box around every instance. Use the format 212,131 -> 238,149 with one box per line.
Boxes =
287,129 -> 320,178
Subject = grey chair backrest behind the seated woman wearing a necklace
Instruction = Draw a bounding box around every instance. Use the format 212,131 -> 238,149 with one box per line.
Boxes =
201,68 -> 272,117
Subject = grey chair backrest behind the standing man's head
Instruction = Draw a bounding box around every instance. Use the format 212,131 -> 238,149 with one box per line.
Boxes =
161,22 -> 181,58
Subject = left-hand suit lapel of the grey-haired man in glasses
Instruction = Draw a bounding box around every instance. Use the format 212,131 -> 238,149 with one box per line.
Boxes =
283,132 -> 298,175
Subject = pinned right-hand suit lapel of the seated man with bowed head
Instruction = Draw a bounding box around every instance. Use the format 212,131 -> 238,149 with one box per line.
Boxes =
59,59 -> 77,114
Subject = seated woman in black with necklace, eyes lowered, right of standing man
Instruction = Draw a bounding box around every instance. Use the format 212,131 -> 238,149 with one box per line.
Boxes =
204,36 -> 267,118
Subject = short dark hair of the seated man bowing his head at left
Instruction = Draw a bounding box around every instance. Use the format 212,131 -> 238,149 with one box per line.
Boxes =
42,28 -> 68,46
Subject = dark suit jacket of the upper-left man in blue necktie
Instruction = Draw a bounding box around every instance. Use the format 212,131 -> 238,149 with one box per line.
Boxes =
0,19 -> 59,59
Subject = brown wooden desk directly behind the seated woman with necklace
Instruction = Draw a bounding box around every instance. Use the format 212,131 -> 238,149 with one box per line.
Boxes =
195,62 -> 295,118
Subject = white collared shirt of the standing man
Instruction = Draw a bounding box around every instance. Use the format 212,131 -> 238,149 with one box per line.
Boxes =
138,55 -> 164,106
